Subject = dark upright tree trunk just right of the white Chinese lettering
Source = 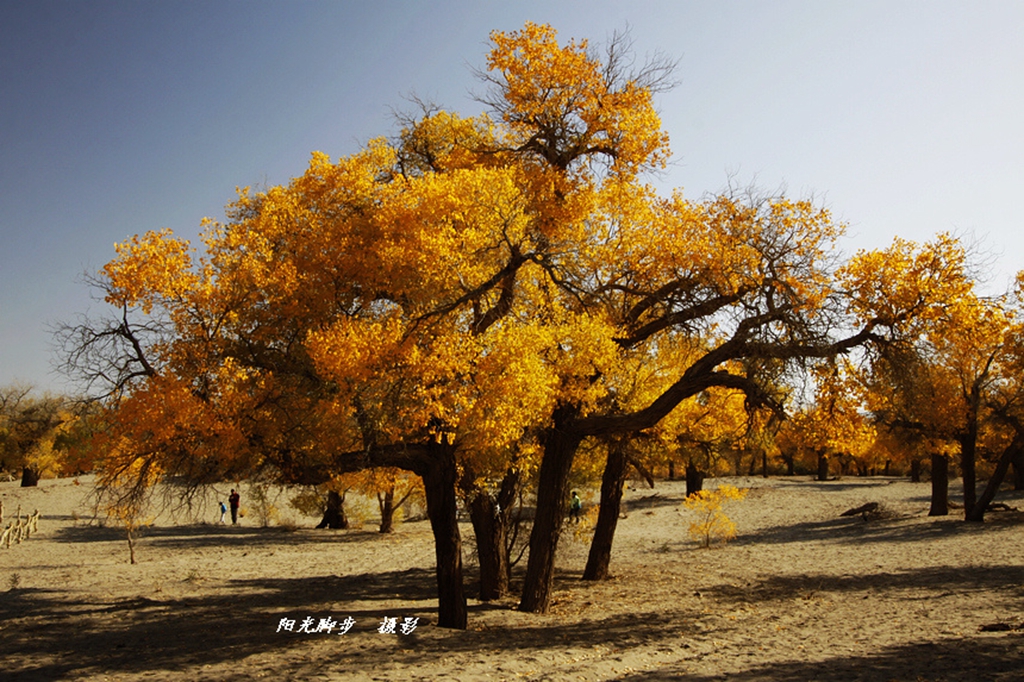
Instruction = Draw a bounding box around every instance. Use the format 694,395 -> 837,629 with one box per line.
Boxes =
418,442 -> 467,630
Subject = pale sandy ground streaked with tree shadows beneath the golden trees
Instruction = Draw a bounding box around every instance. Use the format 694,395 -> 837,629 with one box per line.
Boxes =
0,478 -> 1024,682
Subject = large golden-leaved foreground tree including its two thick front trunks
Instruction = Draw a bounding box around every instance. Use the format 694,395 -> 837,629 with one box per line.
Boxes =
56,24 -> 1007,628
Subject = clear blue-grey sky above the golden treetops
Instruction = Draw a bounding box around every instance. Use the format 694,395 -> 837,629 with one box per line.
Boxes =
0,0 -> 1024,391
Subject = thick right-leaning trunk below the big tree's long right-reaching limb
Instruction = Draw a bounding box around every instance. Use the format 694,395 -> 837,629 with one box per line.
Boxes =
519,408 -> 582,613
